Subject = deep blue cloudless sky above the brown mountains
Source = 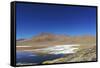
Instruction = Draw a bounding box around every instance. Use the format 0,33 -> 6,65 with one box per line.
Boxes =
16,3 -> 96,39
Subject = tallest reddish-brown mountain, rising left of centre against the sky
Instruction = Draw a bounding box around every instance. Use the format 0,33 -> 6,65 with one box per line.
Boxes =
32,33 -> 70,42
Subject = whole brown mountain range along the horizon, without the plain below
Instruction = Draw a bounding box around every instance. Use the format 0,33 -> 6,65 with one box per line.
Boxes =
17,32 -> 96,43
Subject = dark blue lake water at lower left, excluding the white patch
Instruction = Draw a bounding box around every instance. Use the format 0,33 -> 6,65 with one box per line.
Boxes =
16,51 -> 64,64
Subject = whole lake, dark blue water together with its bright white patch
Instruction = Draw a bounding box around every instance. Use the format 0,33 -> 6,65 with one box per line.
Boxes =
16,45 -> 79,64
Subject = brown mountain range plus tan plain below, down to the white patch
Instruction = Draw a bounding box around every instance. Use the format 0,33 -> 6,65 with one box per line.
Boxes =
17,32 -> 96,49
